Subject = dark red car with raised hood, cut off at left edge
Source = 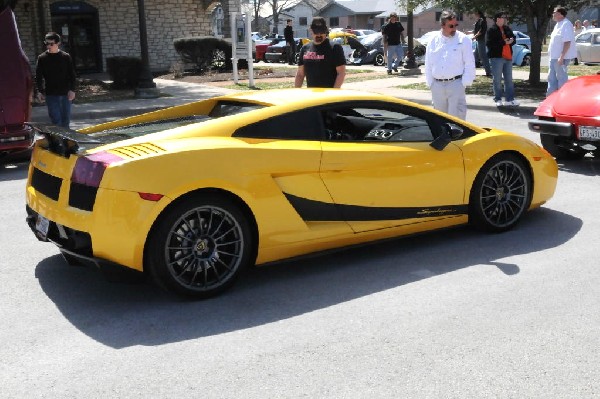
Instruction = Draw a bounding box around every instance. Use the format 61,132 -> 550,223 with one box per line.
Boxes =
0,1 -> 34,159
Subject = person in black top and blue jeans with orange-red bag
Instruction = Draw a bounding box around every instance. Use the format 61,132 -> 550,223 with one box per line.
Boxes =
486,12 -> 519,107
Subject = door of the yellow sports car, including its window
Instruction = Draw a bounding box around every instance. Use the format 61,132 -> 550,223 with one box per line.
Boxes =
320,102 -> 466,232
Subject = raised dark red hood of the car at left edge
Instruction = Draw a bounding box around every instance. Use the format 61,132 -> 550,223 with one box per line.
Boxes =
0,7 -> 32,131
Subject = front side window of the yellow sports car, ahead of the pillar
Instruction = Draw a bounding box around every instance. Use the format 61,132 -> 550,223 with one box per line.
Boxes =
321,103 -> 437,142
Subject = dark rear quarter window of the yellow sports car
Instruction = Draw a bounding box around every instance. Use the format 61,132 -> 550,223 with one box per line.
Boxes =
233,109 -> 323,140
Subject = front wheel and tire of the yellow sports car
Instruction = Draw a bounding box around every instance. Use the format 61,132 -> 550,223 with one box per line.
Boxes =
469,154 -> 532,233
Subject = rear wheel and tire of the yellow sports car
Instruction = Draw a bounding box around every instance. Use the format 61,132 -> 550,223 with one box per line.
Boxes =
145,193 -> 255,298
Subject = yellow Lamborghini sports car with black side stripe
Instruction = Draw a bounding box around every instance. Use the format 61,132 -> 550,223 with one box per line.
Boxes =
26,89 -> 558,297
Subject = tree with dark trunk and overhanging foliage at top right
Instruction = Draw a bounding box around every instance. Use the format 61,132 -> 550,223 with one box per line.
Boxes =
438,0 -> 597,85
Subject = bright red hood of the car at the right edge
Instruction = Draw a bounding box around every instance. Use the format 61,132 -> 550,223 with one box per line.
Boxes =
535,75 -> 600,117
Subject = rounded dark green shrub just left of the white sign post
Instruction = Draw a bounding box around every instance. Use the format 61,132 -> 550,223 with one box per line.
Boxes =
173,36 -> 232,73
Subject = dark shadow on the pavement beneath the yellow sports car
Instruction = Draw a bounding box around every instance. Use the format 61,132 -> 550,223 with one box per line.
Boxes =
35,208 -> 582,348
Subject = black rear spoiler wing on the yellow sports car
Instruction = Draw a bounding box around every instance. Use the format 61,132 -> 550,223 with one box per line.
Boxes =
26,122 -> 104,158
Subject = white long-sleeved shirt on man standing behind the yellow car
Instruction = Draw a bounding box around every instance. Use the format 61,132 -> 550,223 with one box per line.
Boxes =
425,29 -> 475,87
